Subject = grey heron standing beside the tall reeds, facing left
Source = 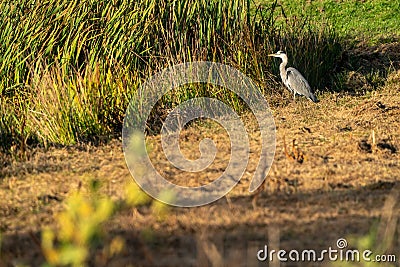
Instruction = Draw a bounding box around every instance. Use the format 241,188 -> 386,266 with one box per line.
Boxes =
268,51 -> 319,103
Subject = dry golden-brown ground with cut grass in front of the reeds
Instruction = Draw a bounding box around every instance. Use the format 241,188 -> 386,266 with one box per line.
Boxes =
0,72 -> 400,266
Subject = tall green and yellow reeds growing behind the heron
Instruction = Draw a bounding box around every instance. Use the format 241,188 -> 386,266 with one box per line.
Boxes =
0,0 -> 341,154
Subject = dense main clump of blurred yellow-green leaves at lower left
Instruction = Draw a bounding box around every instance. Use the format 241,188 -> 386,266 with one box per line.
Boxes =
42,188 -> 117,266
